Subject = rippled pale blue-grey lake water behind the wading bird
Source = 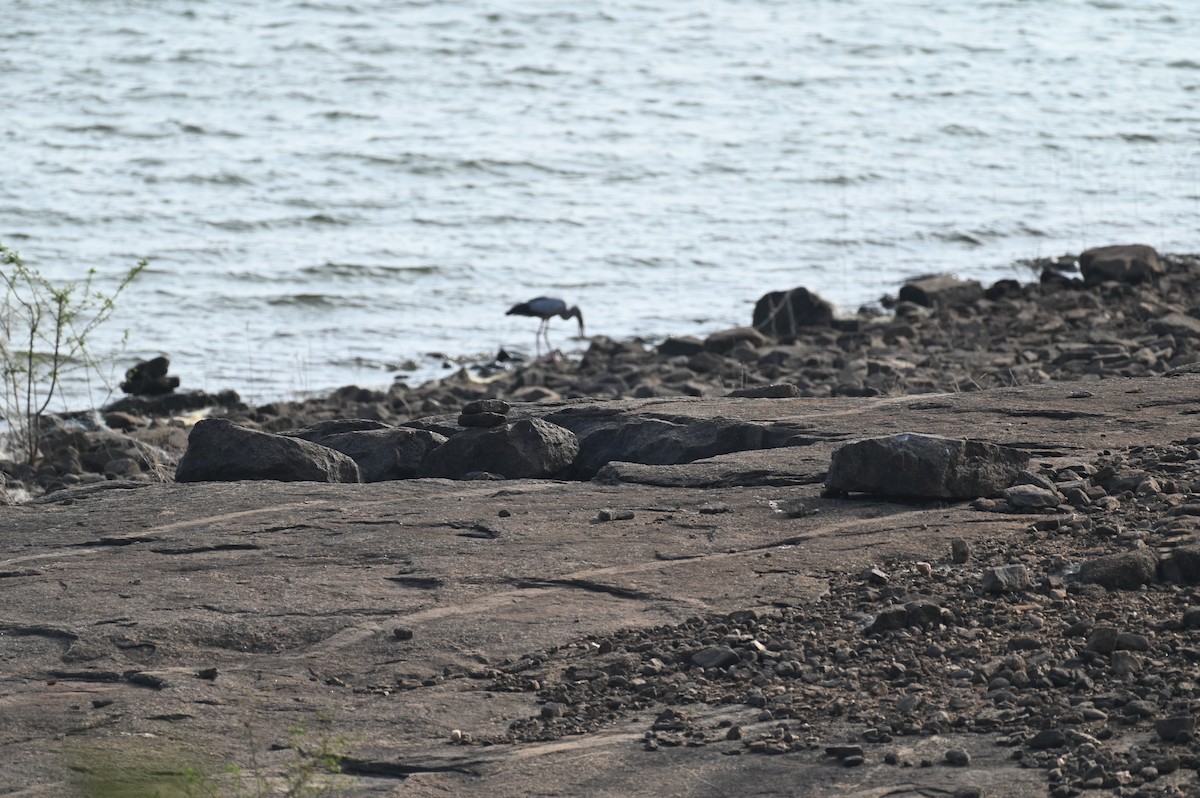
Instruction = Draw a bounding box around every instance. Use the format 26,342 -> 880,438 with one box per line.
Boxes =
0,0 -> 1200,401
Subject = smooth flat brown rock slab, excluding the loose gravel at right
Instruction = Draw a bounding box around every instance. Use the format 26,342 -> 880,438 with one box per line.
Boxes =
0,377 -> 1200,797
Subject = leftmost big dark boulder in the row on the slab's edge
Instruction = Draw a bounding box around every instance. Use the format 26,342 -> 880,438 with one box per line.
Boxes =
175,419 -> 362,482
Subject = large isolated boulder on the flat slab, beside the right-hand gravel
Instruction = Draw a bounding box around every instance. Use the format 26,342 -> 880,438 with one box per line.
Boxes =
826,432 -> 1030,499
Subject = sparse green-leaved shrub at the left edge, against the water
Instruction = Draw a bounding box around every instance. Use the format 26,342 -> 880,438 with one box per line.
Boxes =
0,245 -> 146,467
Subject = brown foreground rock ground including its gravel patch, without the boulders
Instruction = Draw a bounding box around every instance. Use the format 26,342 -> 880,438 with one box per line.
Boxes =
0,373 -> 1200,797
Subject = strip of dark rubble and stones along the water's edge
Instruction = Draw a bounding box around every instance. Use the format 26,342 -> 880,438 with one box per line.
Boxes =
0,245 -> 1200,494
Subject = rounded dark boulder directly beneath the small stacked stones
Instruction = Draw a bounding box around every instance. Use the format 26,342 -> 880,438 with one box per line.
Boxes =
420,419 -> 580,479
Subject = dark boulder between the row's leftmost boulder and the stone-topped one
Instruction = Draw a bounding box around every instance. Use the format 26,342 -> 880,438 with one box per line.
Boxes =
283,419 -> 446,482
